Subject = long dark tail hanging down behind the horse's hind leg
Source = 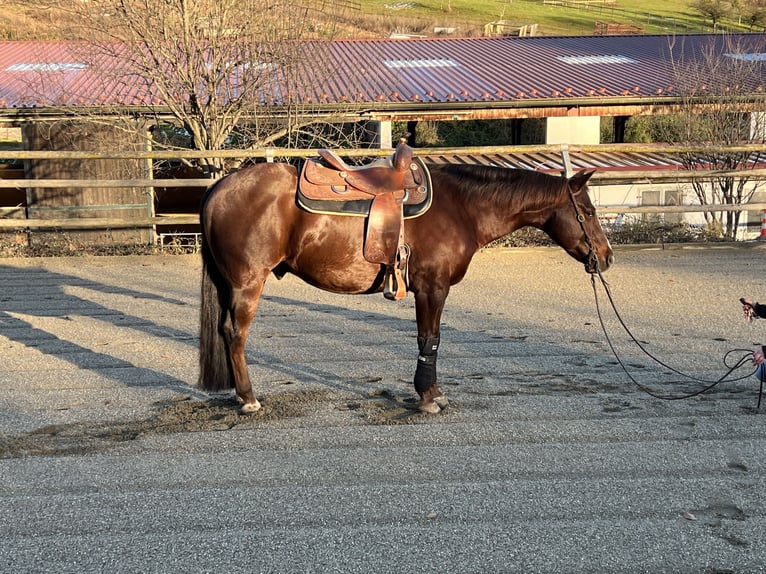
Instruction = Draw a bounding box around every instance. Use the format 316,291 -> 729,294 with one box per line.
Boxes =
198,239 -> 234,391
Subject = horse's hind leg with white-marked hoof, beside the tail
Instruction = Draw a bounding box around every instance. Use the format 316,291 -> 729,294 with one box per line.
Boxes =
222,281 -> 264,413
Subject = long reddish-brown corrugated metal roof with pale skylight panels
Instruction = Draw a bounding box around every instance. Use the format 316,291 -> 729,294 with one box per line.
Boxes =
0,34 -> 766,109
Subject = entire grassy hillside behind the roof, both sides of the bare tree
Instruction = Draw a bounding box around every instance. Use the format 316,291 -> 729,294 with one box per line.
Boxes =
0,0 -> 756,40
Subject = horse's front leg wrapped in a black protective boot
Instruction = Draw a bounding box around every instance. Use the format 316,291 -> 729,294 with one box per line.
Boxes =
415,289 -> 448,414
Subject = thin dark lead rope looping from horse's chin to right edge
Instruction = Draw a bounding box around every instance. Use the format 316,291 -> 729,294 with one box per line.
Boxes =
590,270 -> 766,409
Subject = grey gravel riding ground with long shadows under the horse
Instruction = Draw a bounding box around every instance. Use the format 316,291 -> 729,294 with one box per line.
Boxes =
0,242 -> 766,574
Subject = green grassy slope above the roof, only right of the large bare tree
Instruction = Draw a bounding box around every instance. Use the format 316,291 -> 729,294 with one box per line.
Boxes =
357,0 -> 746,36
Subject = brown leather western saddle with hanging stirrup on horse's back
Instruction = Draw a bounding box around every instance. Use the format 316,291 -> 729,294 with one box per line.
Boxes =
297,138 -> 432,300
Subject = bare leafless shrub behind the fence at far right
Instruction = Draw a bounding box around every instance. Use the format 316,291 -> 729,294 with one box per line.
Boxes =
653,36 -> 766,240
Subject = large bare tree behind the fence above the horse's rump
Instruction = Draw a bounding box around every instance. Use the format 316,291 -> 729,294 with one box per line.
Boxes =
48,0 -> 366,175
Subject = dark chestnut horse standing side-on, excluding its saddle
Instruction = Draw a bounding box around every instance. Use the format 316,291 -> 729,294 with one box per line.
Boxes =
199,163 -> 613,413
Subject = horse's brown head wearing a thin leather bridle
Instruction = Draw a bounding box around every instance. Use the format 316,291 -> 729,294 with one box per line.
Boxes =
542,169 -> 614,273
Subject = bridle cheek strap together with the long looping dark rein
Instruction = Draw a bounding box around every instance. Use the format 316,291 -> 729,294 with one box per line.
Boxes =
567,185 -> 766,409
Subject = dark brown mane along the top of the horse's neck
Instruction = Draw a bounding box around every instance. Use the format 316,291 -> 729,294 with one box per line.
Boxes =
431,164 -> 563,209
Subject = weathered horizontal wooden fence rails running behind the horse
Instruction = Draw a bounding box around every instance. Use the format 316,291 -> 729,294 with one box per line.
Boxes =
0,144 -> 766,232
